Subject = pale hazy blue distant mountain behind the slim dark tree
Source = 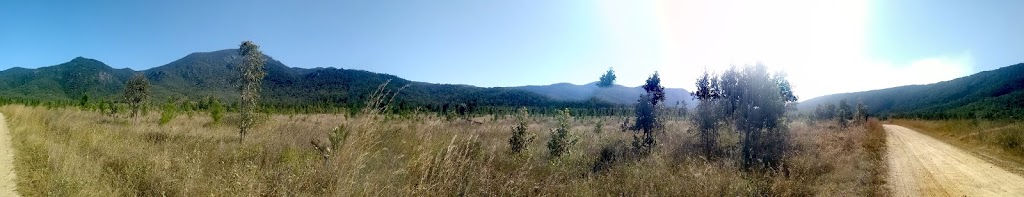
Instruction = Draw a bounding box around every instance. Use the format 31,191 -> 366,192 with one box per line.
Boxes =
513,82 -> 697,108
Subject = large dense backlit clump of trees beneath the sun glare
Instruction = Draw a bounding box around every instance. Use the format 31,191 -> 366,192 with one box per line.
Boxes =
690,65 -> 797,168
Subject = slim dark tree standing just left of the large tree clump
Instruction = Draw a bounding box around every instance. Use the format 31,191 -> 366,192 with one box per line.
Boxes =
630,72 -> 665,153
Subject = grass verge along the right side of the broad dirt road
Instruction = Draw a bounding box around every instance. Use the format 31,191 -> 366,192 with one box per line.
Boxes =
891,119 -> 1024,174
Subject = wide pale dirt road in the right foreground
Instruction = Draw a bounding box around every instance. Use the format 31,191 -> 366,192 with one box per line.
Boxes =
885,125 -> 1024,196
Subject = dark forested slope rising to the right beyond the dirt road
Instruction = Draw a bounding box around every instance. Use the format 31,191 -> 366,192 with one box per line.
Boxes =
800,64 -> 1024,119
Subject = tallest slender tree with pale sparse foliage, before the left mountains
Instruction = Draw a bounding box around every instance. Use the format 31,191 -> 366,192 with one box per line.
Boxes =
239,41 -> 266,143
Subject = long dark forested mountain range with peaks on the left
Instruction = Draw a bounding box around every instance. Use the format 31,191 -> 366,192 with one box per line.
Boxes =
0,49 -> 640,110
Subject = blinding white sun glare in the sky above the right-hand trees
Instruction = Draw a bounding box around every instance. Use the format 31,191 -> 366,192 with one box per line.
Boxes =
601,0 -> 975,101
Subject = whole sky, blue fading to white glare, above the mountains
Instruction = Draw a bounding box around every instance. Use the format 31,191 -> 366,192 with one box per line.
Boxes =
0,0 -> 1024,100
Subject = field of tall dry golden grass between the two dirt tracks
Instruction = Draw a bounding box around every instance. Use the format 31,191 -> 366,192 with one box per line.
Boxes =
0,106 -> 886,196
